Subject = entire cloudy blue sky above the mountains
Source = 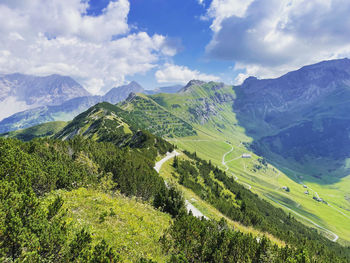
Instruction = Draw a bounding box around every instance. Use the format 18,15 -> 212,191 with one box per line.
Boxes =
0,0 -> 350,94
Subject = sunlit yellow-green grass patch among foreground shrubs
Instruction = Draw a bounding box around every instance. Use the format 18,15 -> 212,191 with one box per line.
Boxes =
48,188 -> 171,262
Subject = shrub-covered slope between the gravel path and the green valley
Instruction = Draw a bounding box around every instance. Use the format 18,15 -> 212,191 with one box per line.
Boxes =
158,151 -> 350,262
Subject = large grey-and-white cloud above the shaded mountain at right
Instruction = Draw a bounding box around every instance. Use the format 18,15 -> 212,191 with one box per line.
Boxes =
206,0 -> 350,81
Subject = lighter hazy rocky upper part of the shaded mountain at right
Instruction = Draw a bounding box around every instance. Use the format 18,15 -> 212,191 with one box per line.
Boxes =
234,59 -> 350,136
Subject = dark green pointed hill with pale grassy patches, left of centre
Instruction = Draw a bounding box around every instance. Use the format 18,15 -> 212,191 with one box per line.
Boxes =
54,102 -> 173,159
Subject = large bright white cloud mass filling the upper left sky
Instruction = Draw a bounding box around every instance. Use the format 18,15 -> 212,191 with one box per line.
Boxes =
0,0 -> 176,93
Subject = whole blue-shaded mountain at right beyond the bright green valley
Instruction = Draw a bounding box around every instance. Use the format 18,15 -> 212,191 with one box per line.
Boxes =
233,59 -> 350,179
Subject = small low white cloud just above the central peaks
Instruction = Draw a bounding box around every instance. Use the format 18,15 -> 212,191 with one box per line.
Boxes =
155,63 -> 220,84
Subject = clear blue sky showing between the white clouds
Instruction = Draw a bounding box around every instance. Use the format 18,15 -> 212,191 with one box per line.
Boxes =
88,0 -> 234,89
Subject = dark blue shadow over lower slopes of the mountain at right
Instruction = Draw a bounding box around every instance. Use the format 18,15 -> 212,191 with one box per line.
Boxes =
233,92 -> 350,185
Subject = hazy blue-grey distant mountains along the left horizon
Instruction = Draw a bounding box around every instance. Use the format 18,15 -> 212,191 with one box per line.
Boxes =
0,76 -> 182,133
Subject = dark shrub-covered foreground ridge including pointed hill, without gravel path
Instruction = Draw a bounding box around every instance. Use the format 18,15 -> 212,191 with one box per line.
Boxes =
0,102 -> 350,263
